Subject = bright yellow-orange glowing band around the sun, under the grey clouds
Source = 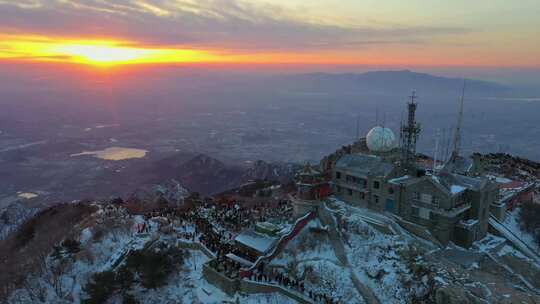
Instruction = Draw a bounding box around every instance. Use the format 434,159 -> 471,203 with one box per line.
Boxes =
0,35 -> 536,67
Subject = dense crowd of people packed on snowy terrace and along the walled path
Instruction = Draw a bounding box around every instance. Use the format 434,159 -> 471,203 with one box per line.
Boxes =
134,200 -> 338,304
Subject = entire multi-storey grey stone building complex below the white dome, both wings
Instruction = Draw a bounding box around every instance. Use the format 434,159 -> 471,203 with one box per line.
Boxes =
323,126 -> 498,247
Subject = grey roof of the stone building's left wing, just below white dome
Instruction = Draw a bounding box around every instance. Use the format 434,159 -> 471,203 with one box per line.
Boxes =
336,154 -> 394,176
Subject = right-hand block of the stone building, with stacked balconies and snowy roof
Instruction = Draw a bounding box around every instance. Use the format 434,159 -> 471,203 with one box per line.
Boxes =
388,172 -> 498,247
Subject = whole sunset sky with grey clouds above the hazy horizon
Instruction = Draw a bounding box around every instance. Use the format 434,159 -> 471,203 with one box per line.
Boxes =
0,0 -> 540,75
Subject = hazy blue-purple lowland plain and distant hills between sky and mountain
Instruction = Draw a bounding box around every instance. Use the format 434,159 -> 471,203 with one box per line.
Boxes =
0,69 -> 540,205
